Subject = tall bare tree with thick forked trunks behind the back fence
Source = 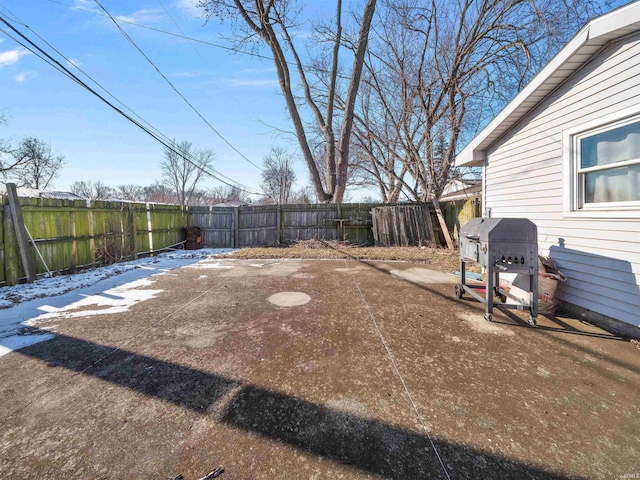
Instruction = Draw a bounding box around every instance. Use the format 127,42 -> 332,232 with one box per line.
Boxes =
199,0 -> 376,203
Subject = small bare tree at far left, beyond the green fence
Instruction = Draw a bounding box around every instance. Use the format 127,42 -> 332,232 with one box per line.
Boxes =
8,137 -> 66,190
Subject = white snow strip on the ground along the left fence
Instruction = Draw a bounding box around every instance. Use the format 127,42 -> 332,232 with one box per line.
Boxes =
0,248 -> 235,357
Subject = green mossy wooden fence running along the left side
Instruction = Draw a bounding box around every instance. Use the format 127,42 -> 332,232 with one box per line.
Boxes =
0,196 -> 188,285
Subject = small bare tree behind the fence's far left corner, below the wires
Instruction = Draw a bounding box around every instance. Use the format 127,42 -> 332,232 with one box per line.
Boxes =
160,141 -> 215,207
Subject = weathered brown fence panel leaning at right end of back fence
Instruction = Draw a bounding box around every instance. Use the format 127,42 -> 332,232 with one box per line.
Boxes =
372,205 -> 440,247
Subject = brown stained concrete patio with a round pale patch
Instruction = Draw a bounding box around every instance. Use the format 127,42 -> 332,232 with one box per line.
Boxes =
0,259 -> 640,480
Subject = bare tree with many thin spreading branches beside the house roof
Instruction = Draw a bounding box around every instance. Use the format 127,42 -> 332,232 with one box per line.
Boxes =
353,0 -> 608,202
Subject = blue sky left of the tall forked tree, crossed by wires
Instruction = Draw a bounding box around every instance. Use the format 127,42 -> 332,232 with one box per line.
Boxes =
0,0 -> 314,199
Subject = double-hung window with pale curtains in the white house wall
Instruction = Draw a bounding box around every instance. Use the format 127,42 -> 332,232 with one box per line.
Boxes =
571,116 -> 640,211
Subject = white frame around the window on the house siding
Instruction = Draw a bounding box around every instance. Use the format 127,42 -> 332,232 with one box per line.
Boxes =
562,105 -> 640,218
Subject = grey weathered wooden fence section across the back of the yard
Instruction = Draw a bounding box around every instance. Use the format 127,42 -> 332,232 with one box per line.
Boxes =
189,203 -> 380,248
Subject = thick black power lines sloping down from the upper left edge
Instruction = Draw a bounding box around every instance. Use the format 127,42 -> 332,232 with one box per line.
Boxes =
0,13 -> 262,195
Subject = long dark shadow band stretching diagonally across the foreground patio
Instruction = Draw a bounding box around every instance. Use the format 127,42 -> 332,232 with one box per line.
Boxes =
5,335 -> 562,479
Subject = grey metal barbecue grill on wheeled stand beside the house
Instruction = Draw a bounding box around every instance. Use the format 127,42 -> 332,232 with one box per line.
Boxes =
456,218 -> 538,325
